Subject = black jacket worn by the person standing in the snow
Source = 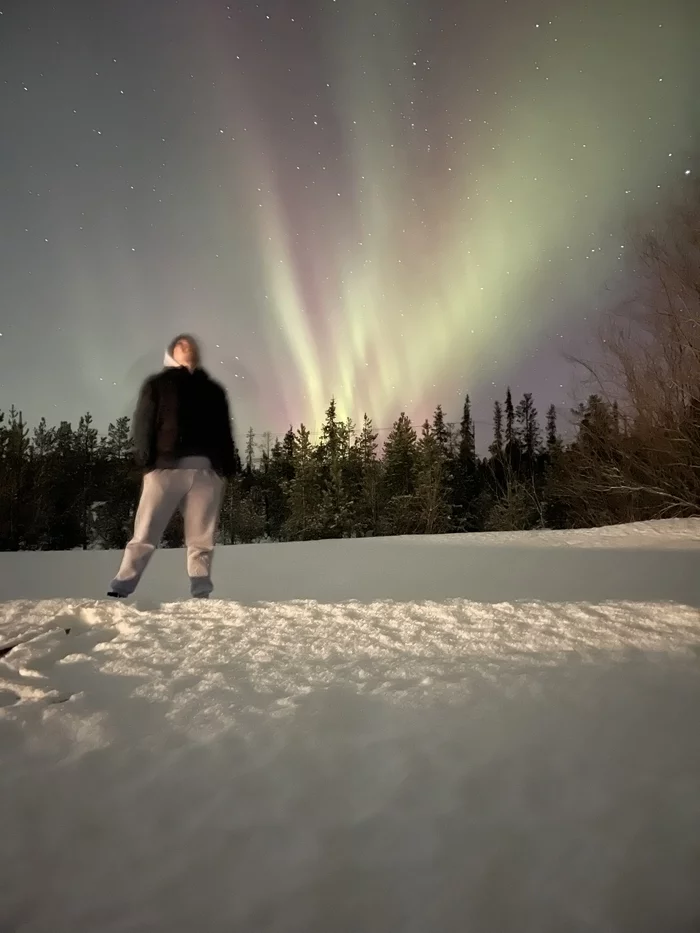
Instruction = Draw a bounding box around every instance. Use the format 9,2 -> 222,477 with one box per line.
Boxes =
134,366 -> 236,477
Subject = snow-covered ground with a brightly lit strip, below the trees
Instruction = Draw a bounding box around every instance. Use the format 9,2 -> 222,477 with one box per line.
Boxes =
0,522 -> 700,933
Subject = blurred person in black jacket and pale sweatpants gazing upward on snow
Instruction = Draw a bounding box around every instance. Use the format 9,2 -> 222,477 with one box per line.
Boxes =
108,334 -> 236,598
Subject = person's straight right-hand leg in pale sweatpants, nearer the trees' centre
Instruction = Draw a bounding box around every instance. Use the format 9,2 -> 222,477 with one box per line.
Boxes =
183,470 -> 224,597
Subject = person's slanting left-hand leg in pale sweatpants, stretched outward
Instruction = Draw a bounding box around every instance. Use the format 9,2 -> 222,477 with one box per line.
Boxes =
109,470 -> 187,596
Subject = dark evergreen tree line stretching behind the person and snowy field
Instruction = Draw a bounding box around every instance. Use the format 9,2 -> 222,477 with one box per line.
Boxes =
0,382 -> 700,550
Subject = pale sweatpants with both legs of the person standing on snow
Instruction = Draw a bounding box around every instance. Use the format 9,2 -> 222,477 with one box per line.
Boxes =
110,461 -> 224,596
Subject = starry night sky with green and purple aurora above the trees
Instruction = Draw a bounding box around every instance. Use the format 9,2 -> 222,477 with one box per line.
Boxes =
0,0 -> 700,446
